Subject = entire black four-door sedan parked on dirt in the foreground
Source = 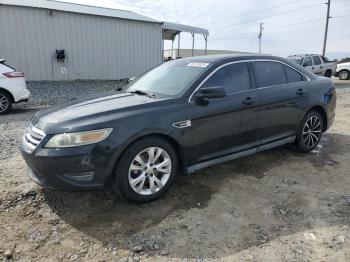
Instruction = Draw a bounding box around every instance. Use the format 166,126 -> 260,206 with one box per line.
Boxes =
22,55 -> 336,202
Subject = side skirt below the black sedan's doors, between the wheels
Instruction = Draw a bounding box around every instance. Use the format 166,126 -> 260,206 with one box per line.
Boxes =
187,136 -> 295,174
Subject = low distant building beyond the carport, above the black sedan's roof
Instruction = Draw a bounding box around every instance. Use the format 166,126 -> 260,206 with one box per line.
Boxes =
164,49 -> 253,60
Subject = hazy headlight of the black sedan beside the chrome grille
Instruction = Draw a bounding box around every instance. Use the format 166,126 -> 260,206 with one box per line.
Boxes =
44,128 -> 113,148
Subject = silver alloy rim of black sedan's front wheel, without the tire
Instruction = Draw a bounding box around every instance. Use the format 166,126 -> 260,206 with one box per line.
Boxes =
128,147 -> 172,195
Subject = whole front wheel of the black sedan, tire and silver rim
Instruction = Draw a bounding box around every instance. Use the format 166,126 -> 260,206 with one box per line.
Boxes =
113,137 -> 178,203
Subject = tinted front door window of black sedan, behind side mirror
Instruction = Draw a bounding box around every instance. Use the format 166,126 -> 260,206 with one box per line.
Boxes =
203,63 -> 250,94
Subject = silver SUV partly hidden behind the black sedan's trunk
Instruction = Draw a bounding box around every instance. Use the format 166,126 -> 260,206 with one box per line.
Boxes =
288,54 -> 336,77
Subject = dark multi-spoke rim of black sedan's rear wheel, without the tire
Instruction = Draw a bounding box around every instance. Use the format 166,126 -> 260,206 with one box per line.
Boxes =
302,116 -> 322,148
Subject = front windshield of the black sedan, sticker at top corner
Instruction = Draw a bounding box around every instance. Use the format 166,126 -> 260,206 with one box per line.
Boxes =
127,60 -> 209,97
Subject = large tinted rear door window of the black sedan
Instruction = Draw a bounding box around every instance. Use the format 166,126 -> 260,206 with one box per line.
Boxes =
254,62 -> 287,87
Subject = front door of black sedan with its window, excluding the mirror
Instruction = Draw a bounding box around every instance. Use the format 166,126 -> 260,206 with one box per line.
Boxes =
191,62 -> 260,163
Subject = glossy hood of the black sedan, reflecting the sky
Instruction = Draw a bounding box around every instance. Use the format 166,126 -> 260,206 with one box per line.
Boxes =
32,93 -> 166,134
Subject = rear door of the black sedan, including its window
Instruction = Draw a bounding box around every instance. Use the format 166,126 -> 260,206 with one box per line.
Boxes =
254,61 -> 308,147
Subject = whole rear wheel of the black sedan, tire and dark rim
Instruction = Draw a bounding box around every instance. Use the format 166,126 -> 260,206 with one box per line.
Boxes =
295,111 -> 323,153
